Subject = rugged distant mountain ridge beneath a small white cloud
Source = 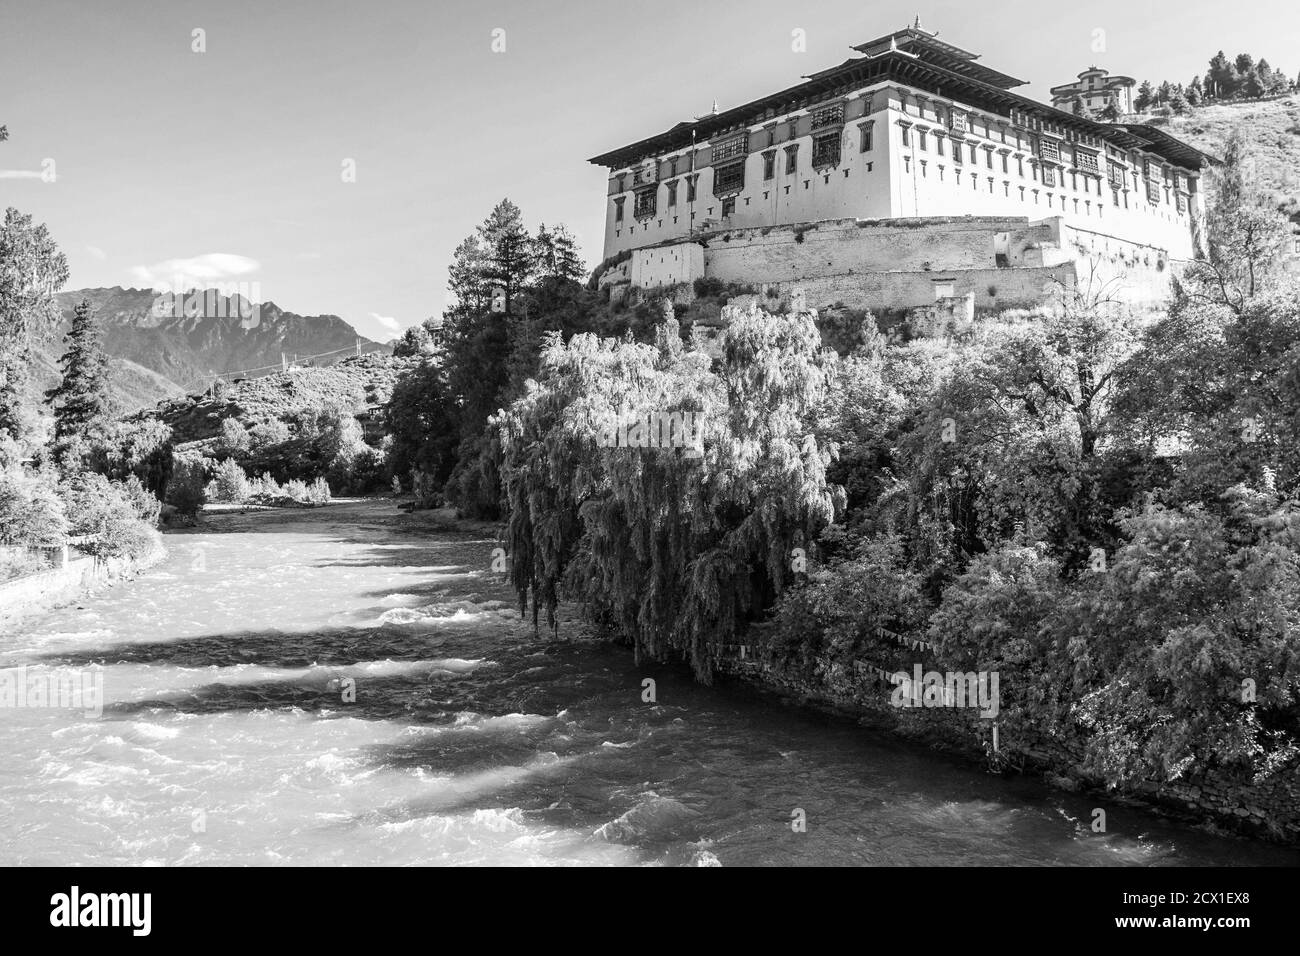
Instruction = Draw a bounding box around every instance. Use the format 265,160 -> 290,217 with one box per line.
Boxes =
43,286 -> 389,411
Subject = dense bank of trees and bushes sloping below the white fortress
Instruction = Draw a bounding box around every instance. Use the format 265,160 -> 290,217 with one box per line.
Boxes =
389,139 -> 1300,786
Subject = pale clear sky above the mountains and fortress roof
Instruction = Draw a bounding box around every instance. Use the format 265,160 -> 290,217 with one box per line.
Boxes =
0,0 -> 1300,341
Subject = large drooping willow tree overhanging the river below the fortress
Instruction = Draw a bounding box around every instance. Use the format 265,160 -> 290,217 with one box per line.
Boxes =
494,303 -> 842,682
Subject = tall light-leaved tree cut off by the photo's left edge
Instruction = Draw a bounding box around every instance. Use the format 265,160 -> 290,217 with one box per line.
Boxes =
0,208 -> 68,437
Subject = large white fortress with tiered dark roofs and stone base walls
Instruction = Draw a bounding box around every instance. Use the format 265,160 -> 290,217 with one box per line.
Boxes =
592,22 -> 1214,311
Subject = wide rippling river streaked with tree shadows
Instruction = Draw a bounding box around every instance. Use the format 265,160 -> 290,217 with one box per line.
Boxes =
0,501 -> 1300,865
